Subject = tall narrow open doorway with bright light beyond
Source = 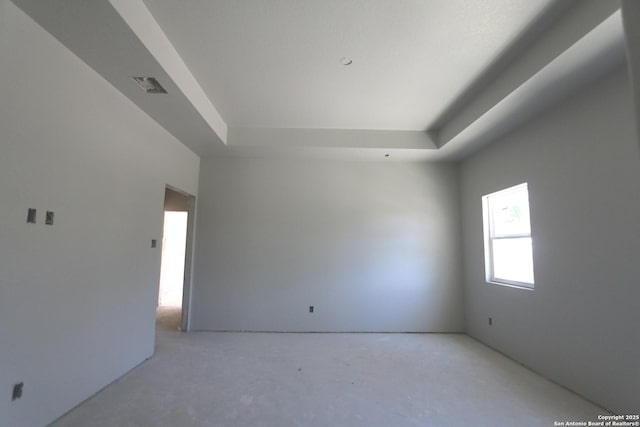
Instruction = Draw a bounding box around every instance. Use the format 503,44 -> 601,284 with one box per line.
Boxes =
156,186 -> 195,331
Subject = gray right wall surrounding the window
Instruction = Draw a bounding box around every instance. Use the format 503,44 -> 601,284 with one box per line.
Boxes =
461,70 -> 640,413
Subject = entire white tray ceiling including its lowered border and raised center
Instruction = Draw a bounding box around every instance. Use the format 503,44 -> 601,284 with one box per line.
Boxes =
11,0 -> 625,161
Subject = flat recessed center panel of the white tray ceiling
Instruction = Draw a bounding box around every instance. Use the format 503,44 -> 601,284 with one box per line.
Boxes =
145,0 -> 555,130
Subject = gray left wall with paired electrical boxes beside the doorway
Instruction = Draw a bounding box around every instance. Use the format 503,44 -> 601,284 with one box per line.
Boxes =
0,0 -> 199,427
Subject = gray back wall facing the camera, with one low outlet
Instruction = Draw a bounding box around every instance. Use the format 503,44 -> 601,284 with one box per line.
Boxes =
192,158 -> 462,331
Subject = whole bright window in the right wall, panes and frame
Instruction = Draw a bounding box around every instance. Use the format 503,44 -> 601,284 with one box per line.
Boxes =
482,183 -> 533,289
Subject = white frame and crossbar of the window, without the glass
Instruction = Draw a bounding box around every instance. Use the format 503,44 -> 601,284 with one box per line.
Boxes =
482,182 -> 535,290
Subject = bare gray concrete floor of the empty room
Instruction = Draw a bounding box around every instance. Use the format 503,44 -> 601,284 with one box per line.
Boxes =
53,310 -> 606,427
